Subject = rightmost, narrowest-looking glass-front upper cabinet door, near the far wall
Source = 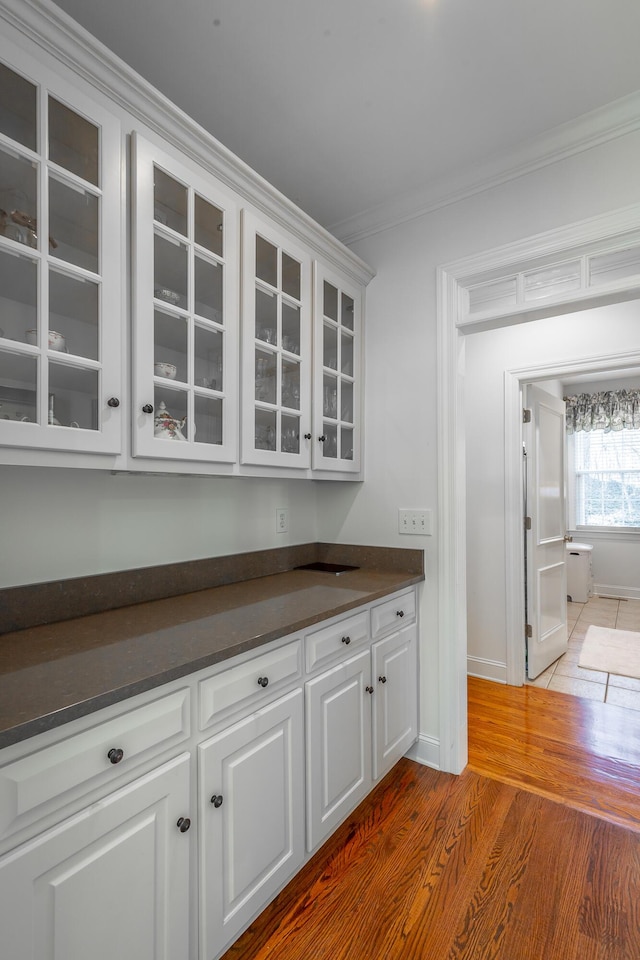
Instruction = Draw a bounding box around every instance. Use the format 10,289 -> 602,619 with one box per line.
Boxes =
313,261 -> 362,473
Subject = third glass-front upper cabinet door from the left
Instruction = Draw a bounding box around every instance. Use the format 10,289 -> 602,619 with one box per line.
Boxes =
242,210 -> 311,468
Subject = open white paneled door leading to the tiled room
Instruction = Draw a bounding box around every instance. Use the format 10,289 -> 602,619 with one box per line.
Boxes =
524,384 -> 568,680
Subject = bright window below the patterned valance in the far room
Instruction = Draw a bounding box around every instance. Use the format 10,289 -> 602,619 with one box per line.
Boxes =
569,430 -> 640,528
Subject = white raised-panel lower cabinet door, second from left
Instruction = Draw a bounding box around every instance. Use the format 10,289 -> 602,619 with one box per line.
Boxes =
198,688 -> 304,960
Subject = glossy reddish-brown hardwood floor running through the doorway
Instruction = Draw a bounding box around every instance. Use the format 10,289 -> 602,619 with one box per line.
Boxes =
225,680 -> 640,960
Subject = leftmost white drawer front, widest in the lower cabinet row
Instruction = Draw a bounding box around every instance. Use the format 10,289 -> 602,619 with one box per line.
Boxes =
0,689 -> 189,836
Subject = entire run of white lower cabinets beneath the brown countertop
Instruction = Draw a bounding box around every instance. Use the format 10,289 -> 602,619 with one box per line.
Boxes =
0,589 -> 418,960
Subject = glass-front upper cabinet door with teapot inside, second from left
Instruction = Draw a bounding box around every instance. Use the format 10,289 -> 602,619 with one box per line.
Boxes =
133,136 -> 238,463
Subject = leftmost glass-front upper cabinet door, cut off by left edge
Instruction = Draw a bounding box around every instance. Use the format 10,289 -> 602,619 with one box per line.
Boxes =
0,55 -> 122,454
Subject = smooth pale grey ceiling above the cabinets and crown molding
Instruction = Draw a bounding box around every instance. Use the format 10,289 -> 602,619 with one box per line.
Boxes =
51,0 -> 640,236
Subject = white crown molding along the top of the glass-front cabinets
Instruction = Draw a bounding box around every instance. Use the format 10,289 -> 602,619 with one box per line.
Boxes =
0,0 -> 375,283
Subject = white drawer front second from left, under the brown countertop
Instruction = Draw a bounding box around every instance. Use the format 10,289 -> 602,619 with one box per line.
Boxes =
200,640 -> 302,730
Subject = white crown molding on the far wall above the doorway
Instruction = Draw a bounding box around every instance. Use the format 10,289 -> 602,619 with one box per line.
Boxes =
329,91 -> 640,244
